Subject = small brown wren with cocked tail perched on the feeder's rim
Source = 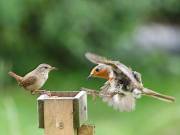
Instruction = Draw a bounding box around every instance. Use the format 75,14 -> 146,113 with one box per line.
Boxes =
8,64 -> 57,94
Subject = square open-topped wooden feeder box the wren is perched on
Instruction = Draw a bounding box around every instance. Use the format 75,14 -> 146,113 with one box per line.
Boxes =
38,91 -> 94,135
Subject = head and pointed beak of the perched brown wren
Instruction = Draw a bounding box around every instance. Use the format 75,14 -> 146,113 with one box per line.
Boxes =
36,64 -> 57,73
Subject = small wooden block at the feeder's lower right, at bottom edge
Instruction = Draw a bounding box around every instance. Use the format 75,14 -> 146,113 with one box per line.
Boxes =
78,125 -> 95,135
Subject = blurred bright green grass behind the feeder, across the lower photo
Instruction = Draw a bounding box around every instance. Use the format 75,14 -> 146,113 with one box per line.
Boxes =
0,72 -> 180,135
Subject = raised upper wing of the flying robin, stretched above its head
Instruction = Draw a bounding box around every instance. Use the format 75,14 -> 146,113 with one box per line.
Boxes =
85,52 -> 139,85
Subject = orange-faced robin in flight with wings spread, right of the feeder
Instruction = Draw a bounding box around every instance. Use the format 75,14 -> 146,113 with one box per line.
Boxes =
86,53 -> 175,111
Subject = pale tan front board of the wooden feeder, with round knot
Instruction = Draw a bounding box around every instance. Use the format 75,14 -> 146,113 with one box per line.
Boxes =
44,99 -> 75,135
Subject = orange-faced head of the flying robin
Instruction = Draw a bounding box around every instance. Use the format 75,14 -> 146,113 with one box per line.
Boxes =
88,64 -> 111,80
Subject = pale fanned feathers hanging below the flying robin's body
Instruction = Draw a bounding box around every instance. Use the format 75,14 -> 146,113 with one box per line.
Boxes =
103,94 -> 136,112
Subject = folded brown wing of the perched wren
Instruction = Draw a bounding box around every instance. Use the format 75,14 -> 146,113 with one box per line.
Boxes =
20,76 -> 37,87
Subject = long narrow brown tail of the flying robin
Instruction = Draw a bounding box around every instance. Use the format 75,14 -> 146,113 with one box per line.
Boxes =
143,88 -> 175,102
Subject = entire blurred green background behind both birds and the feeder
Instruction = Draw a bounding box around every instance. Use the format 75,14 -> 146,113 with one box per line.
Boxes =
0,0 -> 180,135
